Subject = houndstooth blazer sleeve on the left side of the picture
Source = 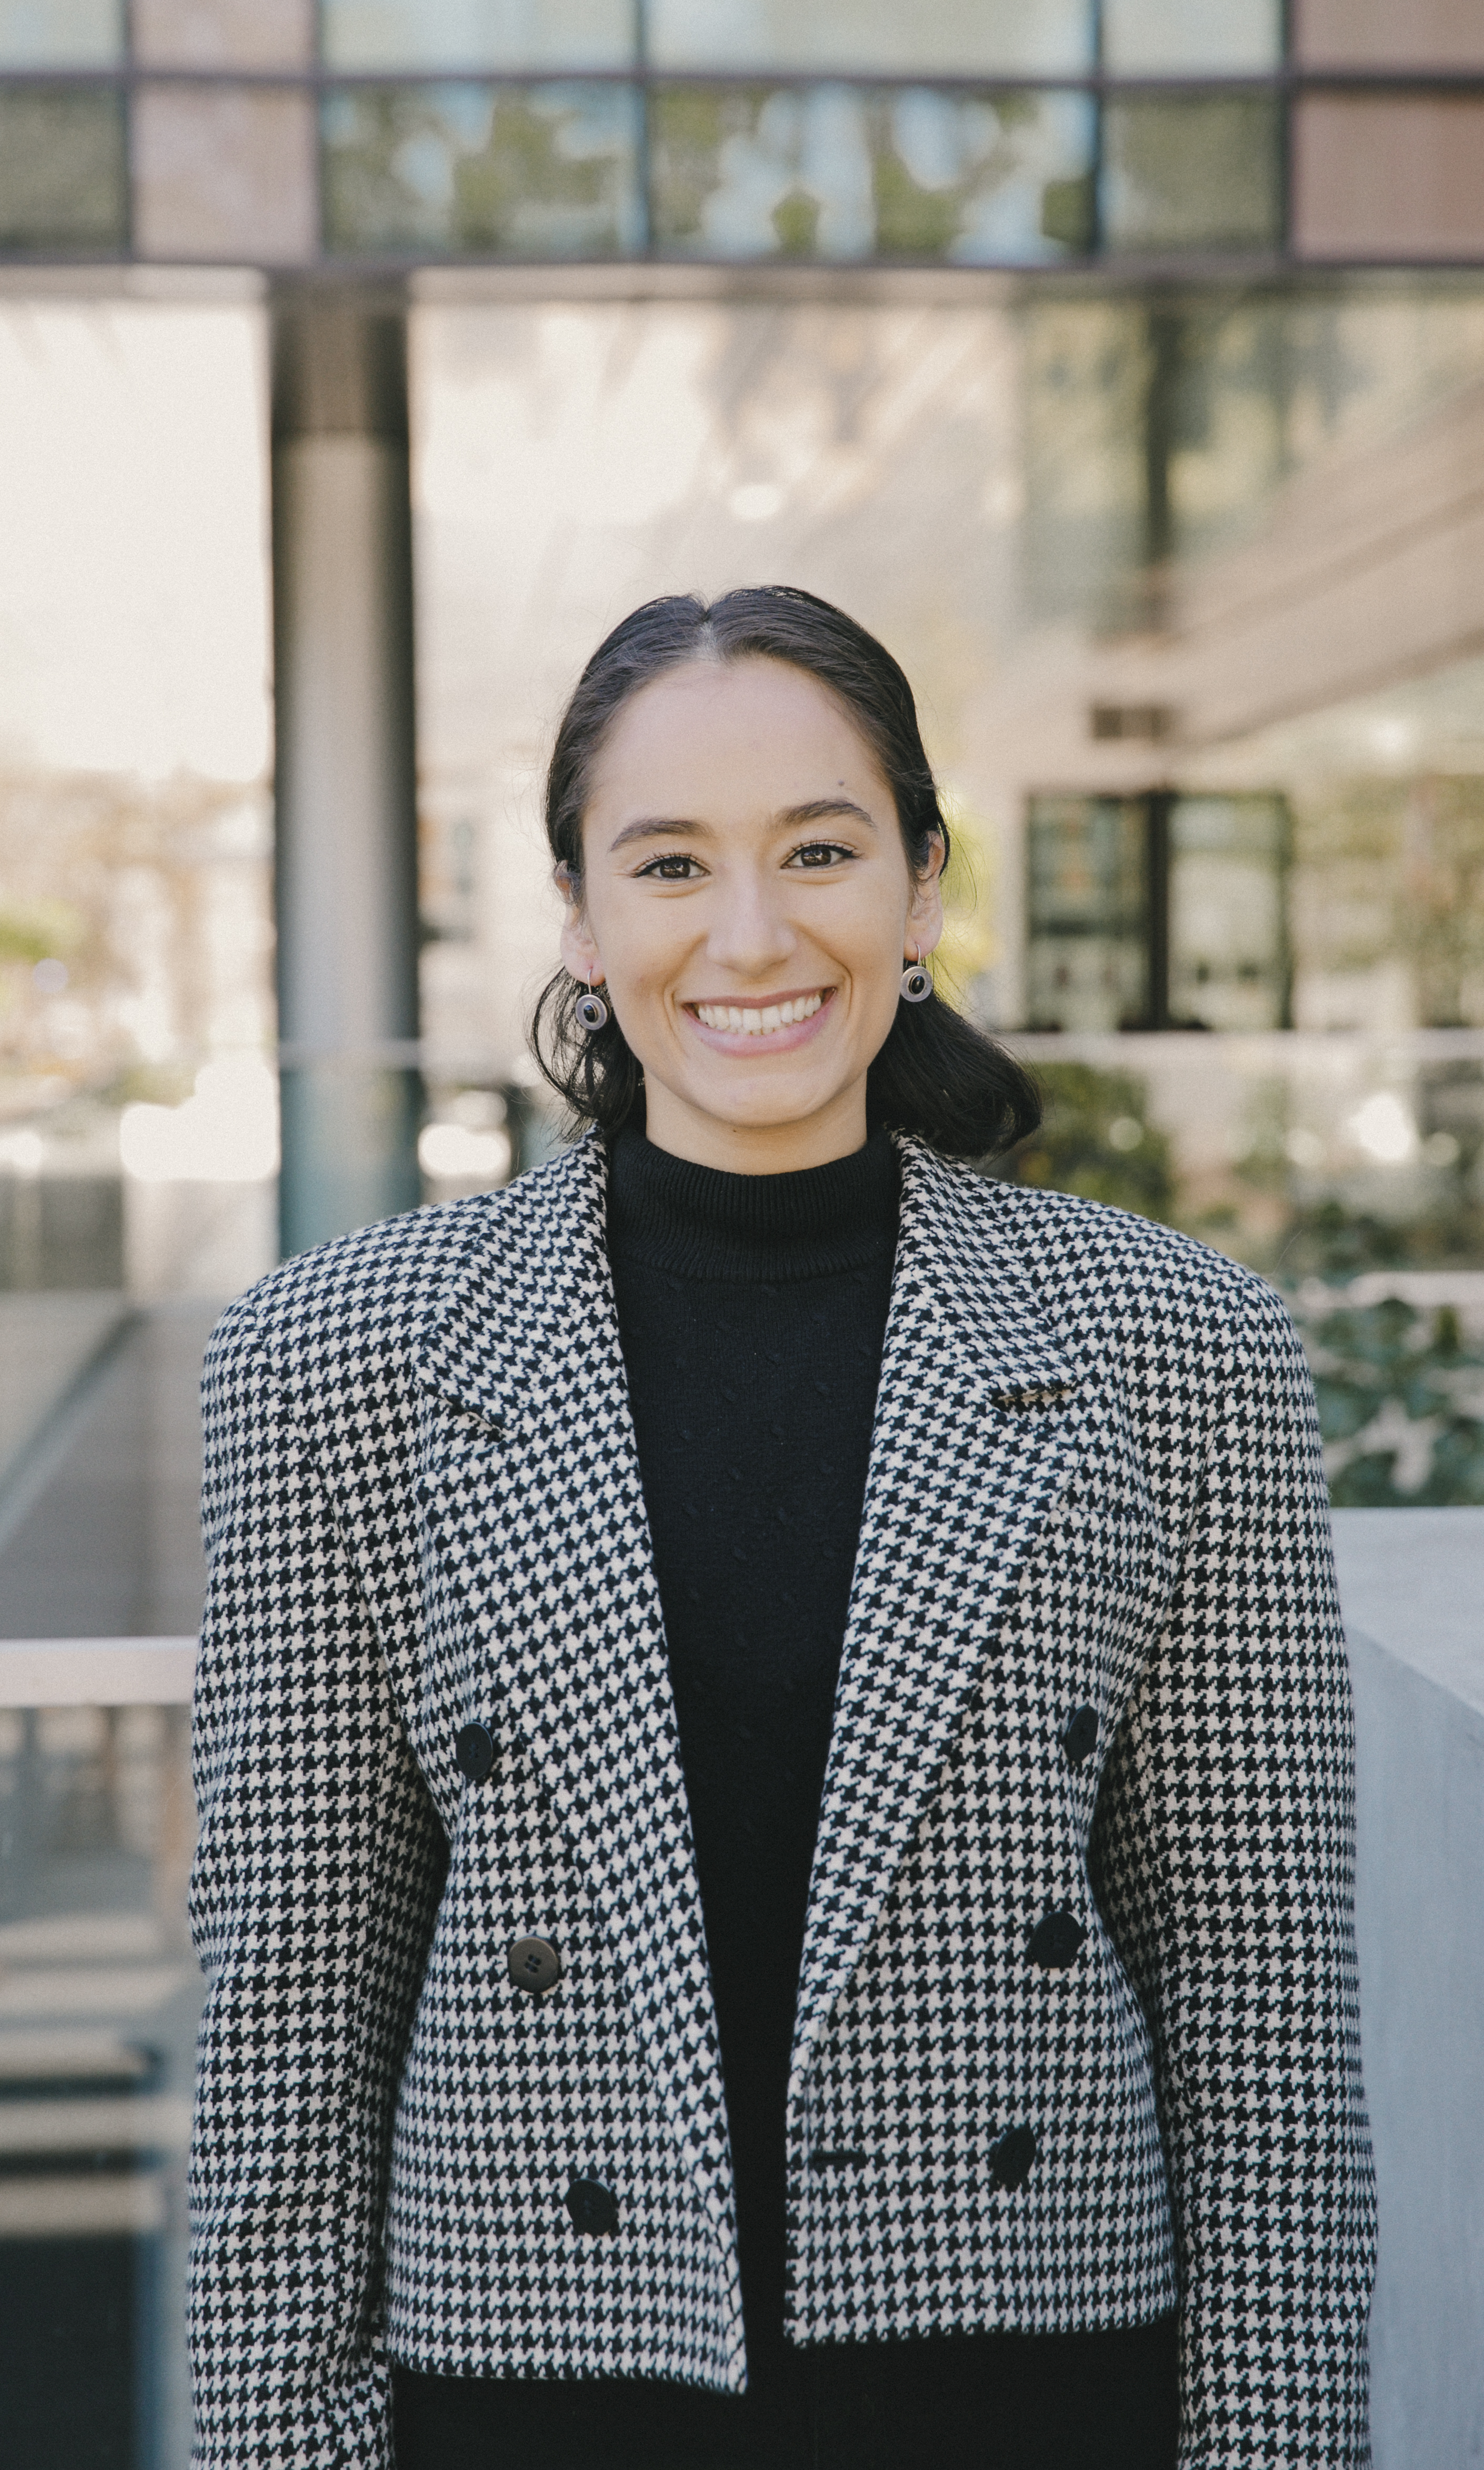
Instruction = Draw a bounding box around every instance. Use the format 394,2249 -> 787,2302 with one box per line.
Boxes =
190,1307 -> 442,2470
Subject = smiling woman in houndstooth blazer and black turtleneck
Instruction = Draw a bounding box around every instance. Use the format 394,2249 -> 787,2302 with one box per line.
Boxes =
193,591 -> 1373,2470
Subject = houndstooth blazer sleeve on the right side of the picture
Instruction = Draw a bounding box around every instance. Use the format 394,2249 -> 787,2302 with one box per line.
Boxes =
1091,1279 -> 1376,2470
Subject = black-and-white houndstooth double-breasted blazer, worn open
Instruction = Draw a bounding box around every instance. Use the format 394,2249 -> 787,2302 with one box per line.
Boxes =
193,1138 -> 1373,2470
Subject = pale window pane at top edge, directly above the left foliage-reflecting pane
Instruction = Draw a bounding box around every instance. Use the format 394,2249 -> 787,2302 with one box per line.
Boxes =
321,0 -> 635,69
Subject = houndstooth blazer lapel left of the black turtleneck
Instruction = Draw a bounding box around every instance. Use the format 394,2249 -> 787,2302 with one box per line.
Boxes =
409,1141 -> 734,2248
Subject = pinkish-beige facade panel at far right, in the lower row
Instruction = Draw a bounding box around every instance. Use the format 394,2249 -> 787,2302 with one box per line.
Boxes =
1294,96 -> 1484,262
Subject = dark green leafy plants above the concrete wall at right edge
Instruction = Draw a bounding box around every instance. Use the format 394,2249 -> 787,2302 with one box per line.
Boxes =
1299,1297 -> 1484,1509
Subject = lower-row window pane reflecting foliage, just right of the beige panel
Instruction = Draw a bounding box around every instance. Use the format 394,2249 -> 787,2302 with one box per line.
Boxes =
324,84 -> 642,257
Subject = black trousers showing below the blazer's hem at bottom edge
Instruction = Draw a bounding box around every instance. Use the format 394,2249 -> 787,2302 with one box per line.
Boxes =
393,2317 -> 1178,2470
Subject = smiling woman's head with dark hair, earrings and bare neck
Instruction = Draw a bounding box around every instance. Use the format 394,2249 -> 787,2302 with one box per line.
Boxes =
536,588 -> 1039,1173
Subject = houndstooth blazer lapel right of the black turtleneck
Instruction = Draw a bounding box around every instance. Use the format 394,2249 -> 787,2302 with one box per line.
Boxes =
790,1141 -> 1081,2099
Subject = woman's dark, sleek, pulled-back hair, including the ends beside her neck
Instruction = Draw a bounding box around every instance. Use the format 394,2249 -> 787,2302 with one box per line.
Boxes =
531,583 -> 1042,1158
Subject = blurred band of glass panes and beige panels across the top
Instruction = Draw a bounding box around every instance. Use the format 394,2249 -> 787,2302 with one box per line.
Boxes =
0,0 -> 1484,267
